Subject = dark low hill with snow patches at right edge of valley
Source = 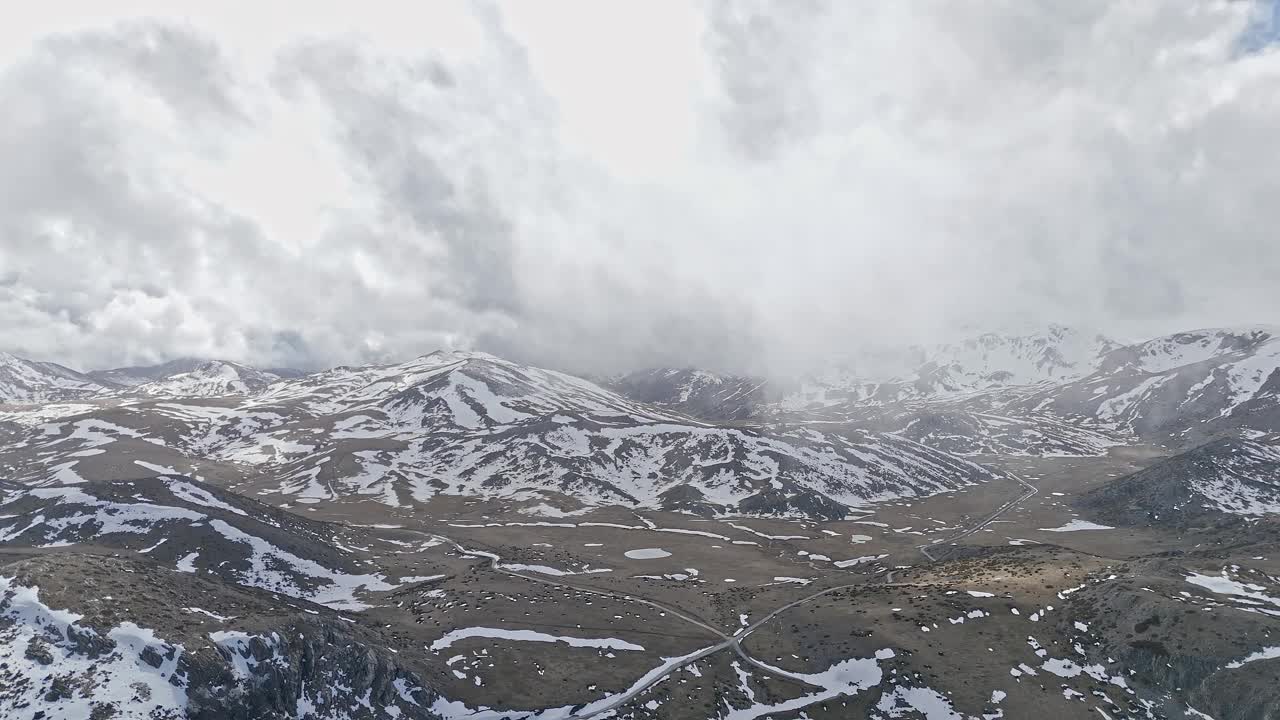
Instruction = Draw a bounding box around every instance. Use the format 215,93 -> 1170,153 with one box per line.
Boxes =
1080,438 -> 1280,527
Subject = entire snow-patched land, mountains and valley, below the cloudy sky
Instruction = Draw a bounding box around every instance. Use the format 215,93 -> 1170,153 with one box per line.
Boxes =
0,328 -> 1280,720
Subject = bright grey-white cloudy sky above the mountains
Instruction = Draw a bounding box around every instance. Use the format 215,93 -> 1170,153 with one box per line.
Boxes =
0,0 -> 1280,374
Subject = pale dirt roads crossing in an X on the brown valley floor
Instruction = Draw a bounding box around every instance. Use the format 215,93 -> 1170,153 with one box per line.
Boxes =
397,473 -> 1039,719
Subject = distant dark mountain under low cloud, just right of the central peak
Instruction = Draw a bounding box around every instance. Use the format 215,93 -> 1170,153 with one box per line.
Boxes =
608,368 -> 769,420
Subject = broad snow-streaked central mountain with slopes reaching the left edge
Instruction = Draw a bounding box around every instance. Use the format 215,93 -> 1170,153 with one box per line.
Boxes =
0,352 -> 993,516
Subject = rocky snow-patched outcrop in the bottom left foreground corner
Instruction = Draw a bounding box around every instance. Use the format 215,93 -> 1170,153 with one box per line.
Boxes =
0,553 -> 438,720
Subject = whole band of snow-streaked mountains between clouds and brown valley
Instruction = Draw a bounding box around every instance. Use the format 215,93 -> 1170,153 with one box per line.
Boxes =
10,327 -> 1280,507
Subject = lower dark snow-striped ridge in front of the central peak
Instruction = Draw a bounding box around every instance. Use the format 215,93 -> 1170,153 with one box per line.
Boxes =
241,420 -> 993,518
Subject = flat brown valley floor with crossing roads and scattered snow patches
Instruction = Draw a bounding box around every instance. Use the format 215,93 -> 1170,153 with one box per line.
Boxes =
232,451 -> 1280,717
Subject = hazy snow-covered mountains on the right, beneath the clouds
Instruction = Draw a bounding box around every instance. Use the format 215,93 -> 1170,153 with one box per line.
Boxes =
769,327 -> 1280,455
